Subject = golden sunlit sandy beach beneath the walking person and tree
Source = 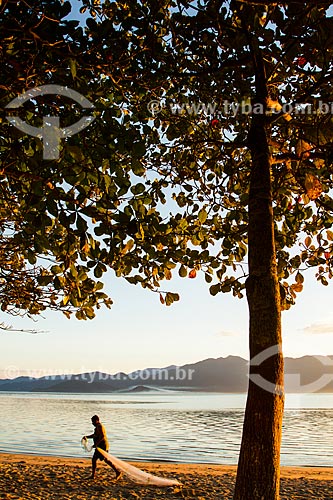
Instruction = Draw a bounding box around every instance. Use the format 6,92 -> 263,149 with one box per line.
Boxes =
0,453 -> 333,500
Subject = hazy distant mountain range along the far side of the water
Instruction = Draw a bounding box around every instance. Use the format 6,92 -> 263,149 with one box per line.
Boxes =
0,356 -> 333,393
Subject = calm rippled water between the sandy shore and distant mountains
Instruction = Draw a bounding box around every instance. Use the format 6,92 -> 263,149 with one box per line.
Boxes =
0,392 -> 333,466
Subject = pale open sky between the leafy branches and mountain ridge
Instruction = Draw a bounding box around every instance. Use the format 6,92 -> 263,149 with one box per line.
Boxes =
0,266 -> 333,378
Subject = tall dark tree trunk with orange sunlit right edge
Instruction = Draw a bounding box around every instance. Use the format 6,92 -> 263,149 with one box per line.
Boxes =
234,94 -> 284,500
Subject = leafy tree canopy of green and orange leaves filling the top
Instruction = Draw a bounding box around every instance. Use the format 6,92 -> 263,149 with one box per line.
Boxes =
0,1 -> 333,318
